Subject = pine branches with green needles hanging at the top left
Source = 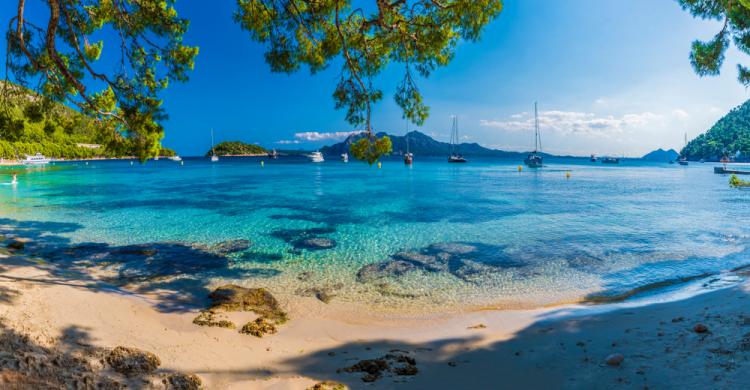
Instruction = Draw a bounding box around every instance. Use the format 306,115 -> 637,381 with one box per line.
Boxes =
3,0 -> 198,159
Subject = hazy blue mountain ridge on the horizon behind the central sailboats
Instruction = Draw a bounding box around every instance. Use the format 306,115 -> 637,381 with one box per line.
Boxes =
320,131 -> 527,158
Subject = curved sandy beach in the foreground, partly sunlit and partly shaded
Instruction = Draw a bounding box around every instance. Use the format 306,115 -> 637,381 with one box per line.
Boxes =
0,242 -> 750,389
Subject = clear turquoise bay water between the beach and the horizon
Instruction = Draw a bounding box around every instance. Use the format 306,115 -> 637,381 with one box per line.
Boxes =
0,158 -> 750,310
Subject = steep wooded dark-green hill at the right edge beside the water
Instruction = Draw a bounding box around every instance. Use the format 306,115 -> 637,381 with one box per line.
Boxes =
681,100 -> 750,161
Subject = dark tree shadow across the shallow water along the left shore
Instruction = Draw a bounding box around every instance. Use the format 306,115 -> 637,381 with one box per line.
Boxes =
0,218 -> 281,312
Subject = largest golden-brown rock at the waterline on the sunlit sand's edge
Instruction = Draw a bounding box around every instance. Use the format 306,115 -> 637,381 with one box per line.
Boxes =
208,284 -> 289,324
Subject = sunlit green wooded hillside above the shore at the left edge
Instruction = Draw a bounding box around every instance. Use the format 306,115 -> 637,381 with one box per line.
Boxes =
0,81 -> 173,159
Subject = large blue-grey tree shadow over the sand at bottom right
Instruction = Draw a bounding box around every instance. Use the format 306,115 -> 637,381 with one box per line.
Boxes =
201,288 -> 750,389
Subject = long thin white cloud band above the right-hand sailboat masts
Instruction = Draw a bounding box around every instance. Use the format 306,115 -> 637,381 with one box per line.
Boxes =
479,111 -> 661,136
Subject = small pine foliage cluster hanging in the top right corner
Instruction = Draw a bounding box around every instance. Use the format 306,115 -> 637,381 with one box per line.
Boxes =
678,0 -> 750,86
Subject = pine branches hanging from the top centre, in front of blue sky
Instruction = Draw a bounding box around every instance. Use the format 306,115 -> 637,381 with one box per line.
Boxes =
235,0 -> 502,163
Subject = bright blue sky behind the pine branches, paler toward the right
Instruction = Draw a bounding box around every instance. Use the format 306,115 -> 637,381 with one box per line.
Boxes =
5,0 -> 748,156
